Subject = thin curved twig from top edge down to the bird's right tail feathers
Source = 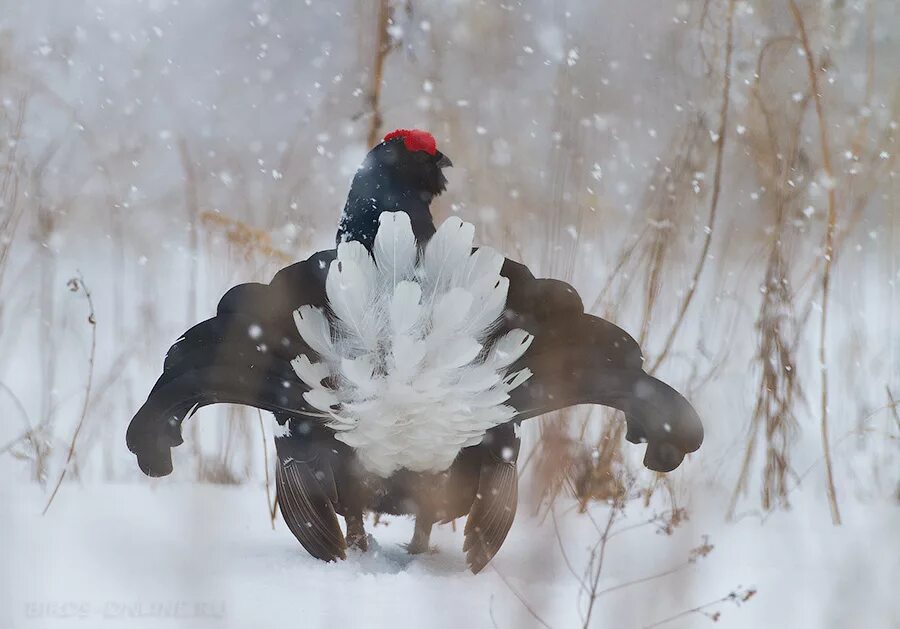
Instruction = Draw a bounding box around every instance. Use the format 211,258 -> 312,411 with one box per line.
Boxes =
647,0 -> 735,374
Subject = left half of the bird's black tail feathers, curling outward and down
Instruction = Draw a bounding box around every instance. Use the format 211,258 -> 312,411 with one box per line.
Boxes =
126,250 -> 335,476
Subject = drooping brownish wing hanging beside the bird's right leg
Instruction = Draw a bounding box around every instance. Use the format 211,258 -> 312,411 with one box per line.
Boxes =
463,424 -> 519,574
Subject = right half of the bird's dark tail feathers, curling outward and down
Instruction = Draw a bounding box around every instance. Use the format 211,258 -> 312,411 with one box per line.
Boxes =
498,260 -> 703,472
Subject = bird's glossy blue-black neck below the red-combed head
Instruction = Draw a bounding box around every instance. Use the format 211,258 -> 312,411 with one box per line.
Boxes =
336,165 -> 435,251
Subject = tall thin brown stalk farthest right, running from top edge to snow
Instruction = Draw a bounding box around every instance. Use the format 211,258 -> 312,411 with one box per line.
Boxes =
791,0 -> 841,525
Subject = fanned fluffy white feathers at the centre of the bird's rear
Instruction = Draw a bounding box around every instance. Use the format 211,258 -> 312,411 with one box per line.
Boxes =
292,212 -> 532,477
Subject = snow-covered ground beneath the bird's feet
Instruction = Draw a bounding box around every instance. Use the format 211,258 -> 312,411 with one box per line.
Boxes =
0,483 -> 900,629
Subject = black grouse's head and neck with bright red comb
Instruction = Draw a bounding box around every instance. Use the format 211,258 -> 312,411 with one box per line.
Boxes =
337,129 -> 453,249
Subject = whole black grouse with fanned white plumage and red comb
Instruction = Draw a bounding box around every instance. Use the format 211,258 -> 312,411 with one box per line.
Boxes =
127,129 -> 703,572
